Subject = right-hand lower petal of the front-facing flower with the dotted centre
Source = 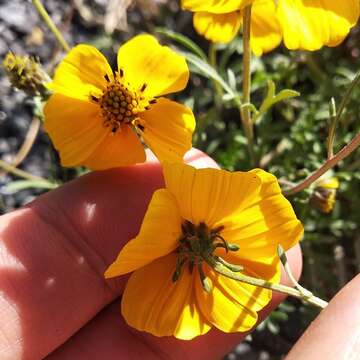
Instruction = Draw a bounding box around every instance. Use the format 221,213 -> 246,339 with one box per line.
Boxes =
139,98 -> 195,162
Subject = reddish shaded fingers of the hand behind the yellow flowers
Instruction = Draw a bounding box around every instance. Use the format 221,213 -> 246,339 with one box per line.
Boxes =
0,150 -> 306,360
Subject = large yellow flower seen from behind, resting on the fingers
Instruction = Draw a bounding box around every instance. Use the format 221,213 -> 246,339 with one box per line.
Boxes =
105,163 -> 303,340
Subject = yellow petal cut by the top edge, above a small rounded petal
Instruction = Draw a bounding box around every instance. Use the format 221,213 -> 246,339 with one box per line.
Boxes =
181,0 -> 253,14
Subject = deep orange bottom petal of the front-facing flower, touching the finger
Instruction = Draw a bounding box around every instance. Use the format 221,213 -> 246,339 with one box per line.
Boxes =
83,125 -> 146,170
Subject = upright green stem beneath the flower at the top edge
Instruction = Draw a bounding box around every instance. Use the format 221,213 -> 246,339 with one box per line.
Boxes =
240,5 -> 256,165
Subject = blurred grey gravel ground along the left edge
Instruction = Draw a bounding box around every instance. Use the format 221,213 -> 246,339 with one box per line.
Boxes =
0,0 -> 68,212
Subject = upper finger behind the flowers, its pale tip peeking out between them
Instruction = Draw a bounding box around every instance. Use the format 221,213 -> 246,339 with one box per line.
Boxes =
0,150 -> 216,359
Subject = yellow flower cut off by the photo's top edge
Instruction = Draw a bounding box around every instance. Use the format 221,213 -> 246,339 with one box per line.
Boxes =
182,0 -> 360,55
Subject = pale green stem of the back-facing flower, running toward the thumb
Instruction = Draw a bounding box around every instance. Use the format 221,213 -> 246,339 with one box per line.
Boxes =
209,262 -> 328,309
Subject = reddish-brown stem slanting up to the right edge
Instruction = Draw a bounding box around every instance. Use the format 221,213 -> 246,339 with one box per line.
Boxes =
283,133 -> 360,196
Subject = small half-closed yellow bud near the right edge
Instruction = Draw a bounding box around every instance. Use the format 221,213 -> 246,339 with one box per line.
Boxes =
310,177 -> 339,214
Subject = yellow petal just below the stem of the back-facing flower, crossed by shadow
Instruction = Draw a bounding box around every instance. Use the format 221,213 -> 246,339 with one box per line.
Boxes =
195,270 -> 260,332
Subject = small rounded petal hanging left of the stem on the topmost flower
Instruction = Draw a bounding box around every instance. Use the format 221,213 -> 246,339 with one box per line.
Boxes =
193,11 -> 241,43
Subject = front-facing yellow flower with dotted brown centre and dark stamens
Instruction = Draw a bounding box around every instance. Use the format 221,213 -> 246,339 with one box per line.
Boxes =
44,35 -> 195,170
